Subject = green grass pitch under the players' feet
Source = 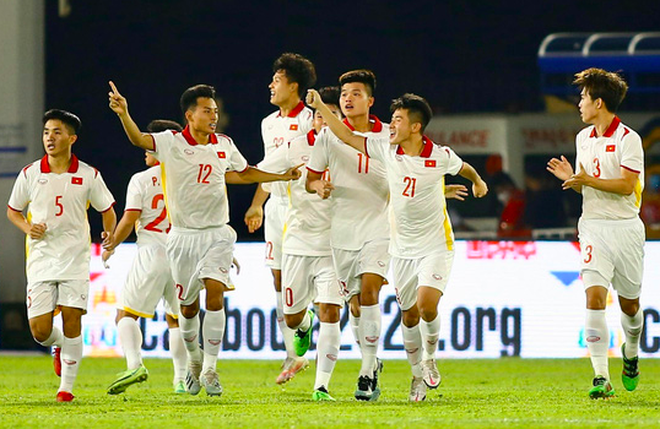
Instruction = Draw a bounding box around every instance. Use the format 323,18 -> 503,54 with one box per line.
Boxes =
0,356 -> 660,429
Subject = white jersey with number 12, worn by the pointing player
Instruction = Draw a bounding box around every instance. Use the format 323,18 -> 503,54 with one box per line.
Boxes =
152,126 -> 248,229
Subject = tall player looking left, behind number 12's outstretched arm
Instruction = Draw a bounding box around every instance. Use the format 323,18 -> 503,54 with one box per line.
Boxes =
245,53 -> 316,384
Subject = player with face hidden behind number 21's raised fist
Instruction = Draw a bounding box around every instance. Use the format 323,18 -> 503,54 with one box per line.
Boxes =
258,88 -> 344,401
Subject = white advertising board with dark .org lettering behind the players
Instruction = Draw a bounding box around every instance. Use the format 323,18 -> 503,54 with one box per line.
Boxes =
83,241 -> 660,359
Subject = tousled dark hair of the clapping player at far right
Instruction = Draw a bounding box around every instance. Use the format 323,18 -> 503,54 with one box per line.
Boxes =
573,67 -> 628,113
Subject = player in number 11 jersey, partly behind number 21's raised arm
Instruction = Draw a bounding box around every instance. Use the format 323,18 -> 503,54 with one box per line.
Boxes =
301,70 -> 390,401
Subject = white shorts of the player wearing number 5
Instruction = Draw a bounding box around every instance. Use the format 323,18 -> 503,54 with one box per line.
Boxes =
26,279 -> 89,319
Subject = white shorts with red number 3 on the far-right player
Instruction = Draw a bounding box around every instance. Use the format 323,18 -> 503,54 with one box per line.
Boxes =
578,218 -> 646,299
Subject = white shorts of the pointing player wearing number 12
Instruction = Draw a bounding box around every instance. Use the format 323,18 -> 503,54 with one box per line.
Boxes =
167,225 -> 236,305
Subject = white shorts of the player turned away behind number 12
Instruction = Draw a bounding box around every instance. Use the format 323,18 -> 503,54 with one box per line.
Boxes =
117,244 -> 179,318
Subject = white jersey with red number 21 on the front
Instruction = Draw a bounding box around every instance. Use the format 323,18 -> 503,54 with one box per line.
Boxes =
365,136 -> 463,258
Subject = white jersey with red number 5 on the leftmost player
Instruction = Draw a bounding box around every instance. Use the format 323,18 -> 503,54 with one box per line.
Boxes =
8,155 -> 115,283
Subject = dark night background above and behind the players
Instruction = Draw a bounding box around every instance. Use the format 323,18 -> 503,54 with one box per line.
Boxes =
46,0 -> 660,241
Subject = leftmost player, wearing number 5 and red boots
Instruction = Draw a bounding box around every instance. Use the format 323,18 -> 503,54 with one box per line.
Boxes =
7,109 -> 117,402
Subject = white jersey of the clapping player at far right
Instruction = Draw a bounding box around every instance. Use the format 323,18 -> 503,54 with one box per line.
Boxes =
575,116 -> 644,219
